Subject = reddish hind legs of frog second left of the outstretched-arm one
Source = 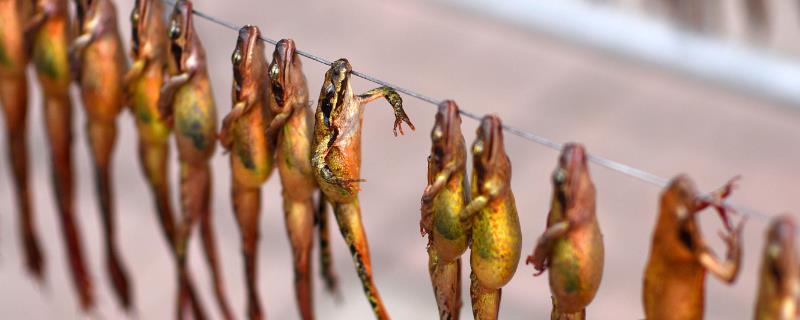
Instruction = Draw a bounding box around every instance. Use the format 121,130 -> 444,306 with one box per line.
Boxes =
233,181 -> 263,319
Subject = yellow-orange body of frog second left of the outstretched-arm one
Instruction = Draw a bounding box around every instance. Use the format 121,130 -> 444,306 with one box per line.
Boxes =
231,102 -> 273,188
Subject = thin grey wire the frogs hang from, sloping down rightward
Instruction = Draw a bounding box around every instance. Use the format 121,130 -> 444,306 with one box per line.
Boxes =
162,0 -> 772,221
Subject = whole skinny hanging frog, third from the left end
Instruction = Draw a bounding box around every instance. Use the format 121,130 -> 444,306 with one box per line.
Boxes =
70,0 -> 133,310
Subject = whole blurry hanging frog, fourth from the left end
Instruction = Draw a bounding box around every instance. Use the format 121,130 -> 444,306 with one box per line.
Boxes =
124,0 -> 204,318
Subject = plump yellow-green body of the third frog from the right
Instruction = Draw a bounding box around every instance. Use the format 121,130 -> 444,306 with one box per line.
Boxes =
548,218 -> 604,313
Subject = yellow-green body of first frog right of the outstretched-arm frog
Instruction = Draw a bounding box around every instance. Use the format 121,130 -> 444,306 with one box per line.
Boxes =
432,170 -> 469,261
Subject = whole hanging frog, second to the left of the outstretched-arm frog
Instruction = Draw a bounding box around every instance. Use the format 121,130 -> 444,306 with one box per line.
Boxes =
220,26 -> 274,319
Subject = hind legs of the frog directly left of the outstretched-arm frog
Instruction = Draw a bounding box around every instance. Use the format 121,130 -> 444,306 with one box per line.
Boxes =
283,194 -> 315,320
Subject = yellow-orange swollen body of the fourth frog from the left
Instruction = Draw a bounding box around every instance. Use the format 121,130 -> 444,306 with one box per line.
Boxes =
130,61 -> 170,143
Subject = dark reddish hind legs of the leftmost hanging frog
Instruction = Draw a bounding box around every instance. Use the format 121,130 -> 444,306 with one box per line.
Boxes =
0,75 -> 45,281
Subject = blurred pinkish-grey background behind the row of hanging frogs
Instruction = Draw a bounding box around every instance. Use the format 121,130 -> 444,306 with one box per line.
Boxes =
0,0 -> 800,319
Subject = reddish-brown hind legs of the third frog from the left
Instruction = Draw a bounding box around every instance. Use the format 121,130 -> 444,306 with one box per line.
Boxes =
86,121 -> 133,310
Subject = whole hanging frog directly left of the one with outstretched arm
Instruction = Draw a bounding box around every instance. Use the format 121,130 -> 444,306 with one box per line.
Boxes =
267,39 -> 336,320
